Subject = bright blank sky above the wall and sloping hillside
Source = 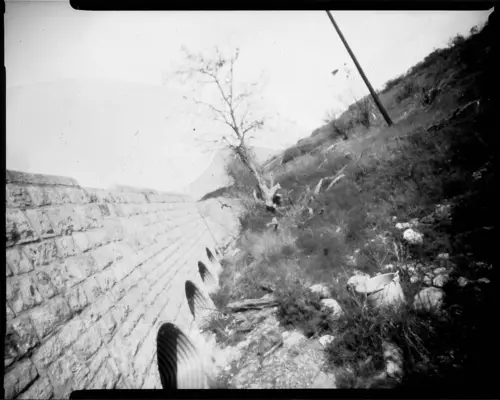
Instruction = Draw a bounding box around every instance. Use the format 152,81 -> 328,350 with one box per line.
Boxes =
5,1 -> 489,191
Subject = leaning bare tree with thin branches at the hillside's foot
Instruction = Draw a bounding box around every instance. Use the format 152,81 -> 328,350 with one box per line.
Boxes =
177,48 -> 280,210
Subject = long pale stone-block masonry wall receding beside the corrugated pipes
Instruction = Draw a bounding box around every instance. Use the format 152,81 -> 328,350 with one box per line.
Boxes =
4,171 -> 230,399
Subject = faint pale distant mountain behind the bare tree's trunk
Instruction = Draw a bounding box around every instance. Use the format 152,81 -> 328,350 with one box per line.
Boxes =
184,146 -> 283,200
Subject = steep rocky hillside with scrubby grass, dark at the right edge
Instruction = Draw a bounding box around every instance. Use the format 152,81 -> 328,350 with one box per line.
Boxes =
198,10 -> 500,396
